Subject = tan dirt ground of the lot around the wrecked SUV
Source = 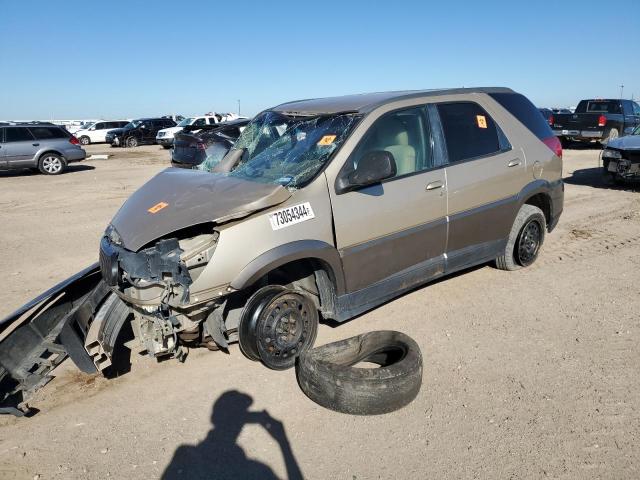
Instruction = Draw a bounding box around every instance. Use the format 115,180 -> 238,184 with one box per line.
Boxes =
0,146 -> 640,480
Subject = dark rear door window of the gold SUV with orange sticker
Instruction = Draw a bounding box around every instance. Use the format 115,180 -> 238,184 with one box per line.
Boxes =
438,102 -> 502,163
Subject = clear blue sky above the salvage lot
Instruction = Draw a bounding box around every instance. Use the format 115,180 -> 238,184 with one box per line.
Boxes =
0,0 -> 640,120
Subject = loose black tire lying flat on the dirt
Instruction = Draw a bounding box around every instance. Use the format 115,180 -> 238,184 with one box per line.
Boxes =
296,331 -> 422,415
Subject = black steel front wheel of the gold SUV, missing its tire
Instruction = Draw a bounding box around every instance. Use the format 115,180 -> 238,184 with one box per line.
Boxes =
238,285 -> 319,370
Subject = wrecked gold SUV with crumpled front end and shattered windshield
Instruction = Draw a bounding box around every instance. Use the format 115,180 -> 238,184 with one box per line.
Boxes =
0,88 -> 564,408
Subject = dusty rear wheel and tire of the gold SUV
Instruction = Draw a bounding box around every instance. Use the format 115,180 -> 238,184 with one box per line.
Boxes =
496,204 -> 547,271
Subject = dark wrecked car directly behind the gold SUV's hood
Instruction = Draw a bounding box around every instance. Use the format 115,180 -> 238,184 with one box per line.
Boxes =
171,118 -> 249,170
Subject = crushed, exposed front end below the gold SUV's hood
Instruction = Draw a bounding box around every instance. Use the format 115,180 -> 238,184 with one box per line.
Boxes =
100,227 -> 219,359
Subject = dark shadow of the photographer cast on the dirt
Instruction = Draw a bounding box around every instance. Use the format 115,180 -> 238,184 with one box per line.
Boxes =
162,390 -> 303,480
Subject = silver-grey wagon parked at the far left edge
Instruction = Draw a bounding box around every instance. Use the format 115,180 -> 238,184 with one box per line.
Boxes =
0,123 -> 86,175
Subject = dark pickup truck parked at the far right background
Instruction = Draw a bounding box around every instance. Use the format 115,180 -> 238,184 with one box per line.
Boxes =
549,99 -> 640,144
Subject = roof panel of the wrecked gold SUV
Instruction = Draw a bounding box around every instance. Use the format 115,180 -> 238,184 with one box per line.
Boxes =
271,87 -> 514,114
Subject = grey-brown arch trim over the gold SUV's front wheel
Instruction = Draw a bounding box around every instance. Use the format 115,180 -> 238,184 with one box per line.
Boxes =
231,240 -> 345,295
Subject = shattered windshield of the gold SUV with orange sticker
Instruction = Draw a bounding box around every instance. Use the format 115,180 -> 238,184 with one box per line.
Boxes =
229,111 -> 361,188
